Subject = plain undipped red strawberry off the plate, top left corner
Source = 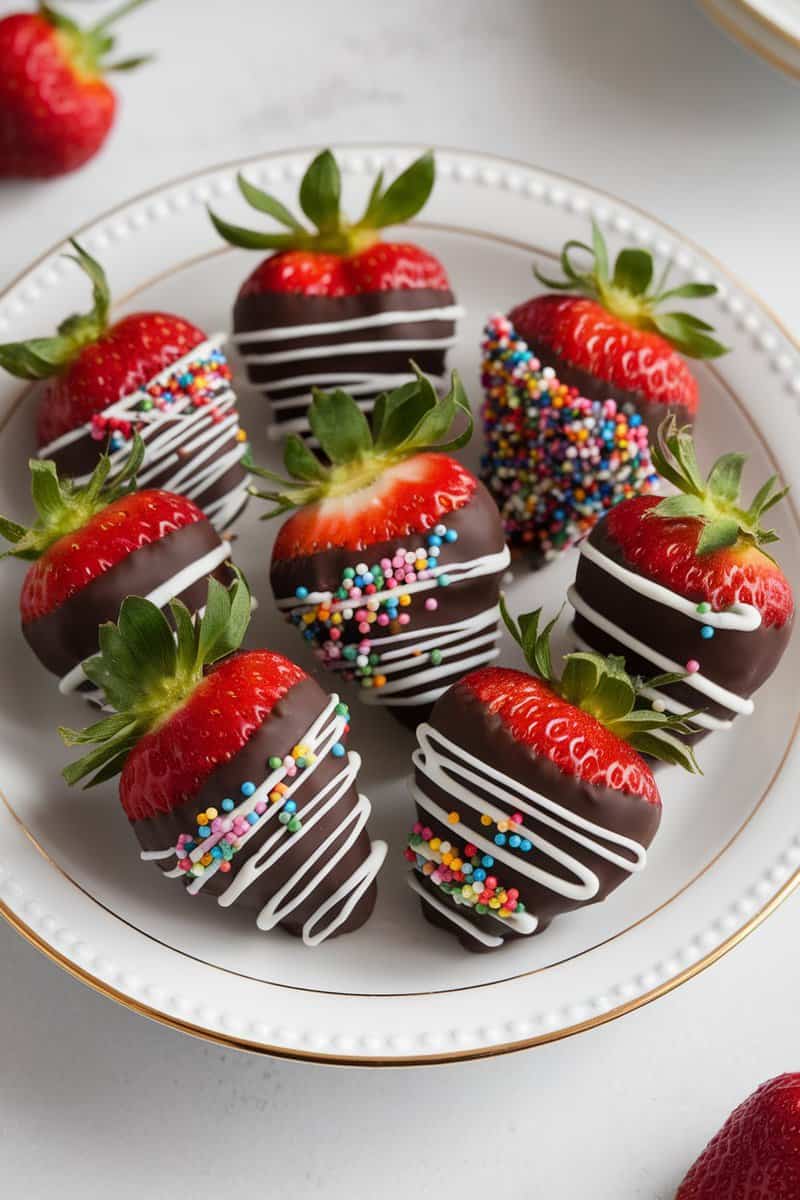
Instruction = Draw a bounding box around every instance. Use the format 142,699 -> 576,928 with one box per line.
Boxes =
0,0 -> 148,179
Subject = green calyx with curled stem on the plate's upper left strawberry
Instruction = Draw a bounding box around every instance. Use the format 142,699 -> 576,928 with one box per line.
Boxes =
0,240 -> 112,379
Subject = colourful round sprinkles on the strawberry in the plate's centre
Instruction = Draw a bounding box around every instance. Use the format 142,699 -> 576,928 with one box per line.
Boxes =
289,523 -> 458,689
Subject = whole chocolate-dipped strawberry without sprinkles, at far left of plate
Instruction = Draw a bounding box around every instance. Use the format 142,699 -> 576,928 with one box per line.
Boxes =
0,434 -> 230,698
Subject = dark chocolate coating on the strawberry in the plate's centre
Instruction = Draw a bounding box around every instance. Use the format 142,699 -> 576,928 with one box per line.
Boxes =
270,484 -> 505,728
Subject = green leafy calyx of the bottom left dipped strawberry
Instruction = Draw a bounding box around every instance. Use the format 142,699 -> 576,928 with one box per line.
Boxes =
59,568 -> 251,787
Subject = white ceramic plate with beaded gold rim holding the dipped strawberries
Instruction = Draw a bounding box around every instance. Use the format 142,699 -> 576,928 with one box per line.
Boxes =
0,148 -> 800,1064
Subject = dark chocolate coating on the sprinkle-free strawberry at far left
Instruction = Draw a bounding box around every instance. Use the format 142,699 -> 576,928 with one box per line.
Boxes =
23,521 -> 230,676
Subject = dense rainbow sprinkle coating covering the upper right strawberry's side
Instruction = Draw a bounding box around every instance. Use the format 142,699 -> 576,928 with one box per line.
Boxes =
481,316 -> 657,560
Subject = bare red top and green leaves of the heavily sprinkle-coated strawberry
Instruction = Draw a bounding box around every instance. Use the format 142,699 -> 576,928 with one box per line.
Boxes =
509,224 -> 724,433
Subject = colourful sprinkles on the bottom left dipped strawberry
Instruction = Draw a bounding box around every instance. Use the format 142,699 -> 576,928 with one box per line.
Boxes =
175,702 -> 350,878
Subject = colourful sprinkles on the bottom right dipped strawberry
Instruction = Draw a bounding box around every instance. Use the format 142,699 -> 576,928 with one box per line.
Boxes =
404,812 -> 531,920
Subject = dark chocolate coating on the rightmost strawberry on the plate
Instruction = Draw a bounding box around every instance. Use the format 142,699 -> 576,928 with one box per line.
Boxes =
573,517 -> 793,720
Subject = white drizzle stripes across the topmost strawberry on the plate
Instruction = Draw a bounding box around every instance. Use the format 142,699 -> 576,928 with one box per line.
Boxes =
231,304 -> 464,440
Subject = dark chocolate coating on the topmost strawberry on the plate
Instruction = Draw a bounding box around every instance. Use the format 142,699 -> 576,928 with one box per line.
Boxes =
234,288 -> 456,434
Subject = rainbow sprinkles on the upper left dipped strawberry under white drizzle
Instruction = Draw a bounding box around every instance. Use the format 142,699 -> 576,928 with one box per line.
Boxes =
90,347 -> 237,450
